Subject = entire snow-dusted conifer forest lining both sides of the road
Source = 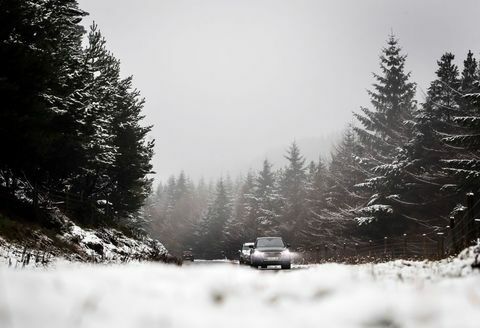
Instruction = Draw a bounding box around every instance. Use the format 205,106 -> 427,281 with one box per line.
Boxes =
0,0 -> 480,258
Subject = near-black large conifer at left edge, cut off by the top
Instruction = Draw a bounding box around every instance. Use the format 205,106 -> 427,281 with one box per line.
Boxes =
0,0 -> 86,192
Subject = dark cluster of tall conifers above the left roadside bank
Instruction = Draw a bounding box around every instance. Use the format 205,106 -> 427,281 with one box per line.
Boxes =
0,0 -> 153,231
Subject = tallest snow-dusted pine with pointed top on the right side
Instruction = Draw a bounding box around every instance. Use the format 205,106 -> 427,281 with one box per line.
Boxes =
354,35 -> 416,236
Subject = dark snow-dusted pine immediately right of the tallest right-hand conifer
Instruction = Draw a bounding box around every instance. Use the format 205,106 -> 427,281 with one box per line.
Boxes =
404,53 -> 470,232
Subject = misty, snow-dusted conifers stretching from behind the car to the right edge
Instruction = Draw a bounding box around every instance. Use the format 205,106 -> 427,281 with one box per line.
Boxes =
146,35 -> 480,258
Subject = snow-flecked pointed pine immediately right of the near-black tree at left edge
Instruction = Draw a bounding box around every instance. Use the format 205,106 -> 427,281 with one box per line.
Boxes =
69,23 -> 120,208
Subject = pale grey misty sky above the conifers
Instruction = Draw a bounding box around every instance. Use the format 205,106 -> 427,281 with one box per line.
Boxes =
79,0 -> 480,179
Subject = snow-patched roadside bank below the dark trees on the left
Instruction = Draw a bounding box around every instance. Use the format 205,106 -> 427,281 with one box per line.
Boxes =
0,218 -> 168,268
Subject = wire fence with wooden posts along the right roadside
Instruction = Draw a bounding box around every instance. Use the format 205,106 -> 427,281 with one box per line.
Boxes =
299,193 -> 480,263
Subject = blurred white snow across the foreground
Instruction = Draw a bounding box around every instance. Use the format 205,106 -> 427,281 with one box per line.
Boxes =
0,247 -> 480,328
